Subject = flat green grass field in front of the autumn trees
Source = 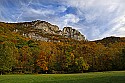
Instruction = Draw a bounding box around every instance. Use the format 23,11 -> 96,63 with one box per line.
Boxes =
0,71 -> 125,83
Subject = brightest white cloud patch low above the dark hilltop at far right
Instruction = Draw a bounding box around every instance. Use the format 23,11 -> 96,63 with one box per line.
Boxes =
96,15 -> 125,38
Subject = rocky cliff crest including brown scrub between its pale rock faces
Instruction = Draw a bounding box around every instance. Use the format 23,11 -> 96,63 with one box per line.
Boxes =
10,20 -> 85,41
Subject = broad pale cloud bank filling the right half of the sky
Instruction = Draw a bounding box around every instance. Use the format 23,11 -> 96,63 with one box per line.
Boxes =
60,0 -> 125,40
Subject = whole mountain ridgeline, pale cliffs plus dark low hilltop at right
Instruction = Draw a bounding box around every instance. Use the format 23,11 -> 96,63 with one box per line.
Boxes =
0,20 -> 125,43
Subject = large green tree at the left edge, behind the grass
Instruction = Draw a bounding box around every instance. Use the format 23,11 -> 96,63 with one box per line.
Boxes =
0,41 -> 19,74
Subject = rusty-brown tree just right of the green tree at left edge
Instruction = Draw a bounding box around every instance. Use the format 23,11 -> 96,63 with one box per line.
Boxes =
17,46 -> 34,73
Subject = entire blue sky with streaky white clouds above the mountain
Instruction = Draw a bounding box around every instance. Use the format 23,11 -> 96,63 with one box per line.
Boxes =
0,0 -> 125,40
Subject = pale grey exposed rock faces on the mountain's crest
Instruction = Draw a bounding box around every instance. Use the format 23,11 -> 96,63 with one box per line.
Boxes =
16,20 -> 85,41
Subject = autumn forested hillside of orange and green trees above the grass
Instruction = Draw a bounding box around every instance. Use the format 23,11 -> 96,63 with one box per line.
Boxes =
0,22 -> 125,74
